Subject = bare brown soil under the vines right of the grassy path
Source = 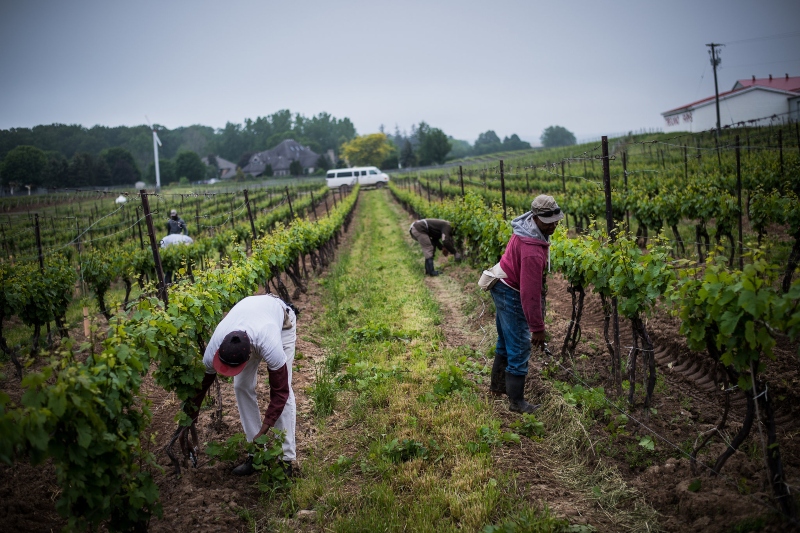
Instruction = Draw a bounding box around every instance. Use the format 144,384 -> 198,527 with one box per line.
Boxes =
427,256 -> 800,532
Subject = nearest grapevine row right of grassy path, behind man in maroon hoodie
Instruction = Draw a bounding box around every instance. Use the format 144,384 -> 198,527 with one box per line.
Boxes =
390,184 -> 800,514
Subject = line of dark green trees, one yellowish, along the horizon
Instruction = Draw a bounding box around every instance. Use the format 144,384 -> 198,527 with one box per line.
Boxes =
0,109 -> 575,188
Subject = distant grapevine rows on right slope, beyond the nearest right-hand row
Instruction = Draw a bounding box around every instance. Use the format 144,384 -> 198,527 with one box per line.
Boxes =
398,123 -> 800,280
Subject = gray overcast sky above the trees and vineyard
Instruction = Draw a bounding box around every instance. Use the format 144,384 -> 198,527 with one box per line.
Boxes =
0,0 -> 800,142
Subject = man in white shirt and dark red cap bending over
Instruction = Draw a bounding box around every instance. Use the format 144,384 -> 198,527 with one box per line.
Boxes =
187,295 -> 297,476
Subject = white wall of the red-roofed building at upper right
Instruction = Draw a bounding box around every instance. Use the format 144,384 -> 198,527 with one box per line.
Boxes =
664,89 -> 789,132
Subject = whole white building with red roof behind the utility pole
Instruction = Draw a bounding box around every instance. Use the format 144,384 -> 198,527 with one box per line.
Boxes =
661,74 -> 800,132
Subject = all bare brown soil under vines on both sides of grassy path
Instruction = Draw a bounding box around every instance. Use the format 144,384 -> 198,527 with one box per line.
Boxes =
0,187 -> 800,532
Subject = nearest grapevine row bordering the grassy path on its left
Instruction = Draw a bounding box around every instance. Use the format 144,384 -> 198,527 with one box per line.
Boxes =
0,185 -> 358,531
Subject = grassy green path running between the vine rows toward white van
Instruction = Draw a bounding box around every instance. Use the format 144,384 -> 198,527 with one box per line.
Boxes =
286,191 -> 586,532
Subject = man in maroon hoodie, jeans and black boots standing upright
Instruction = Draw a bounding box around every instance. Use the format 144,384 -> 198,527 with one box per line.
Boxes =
490,194 -> 564,413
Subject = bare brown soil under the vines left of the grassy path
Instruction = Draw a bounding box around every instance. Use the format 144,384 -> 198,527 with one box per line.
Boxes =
0,193 -> 358,533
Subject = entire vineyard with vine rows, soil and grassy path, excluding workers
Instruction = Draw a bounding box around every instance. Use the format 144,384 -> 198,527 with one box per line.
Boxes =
0,125 -> 800,531
